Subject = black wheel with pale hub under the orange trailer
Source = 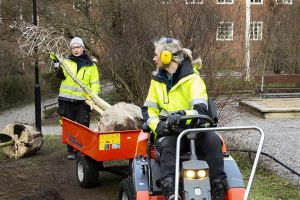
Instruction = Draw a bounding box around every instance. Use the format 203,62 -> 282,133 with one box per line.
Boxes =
76,155 -> 99,188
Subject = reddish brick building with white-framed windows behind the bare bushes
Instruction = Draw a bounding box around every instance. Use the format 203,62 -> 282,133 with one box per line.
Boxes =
185,0 -> 299,67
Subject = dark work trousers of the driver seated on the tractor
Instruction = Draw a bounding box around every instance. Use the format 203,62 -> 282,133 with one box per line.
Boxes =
155,131 -> 226,180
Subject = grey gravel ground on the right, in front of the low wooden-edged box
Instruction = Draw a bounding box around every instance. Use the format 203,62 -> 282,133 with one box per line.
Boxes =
224,103 -> 300,185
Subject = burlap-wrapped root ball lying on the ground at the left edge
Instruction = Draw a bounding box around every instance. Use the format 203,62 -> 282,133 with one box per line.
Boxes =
0,123 -> 43,159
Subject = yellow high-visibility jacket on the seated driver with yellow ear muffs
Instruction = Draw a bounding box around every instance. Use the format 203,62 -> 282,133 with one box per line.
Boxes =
142,60 -> 208,134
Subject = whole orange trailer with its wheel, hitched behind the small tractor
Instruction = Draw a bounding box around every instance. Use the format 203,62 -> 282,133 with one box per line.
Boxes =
62,118 -> 142,187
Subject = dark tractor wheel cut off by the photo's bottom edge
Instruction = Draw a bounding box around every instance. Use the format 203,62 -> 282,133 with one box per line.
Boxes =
119,177 -> 135,200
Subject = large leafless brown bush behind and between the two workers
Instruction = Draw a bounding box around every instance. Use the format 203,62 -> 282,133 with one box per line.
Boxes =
36,0 -> 232,105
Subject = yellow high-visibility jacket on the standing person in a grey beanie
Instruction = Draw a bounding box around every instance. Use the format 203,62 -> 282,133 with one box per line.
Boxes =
59,56 -> 100,100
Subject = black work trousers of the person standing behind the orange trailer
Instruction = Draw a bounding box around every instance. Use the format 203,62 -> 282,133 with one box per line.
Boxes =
57,100 -> 91,152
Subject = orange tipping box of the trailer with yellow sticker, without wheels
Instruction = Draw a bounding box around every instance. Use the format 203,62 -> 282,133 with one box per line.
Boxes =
62,118 -> 141,162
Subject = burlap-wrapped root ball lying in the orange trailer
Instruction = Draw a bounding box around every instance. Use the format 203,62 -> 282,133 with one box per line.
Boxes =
98,102 -> 143,132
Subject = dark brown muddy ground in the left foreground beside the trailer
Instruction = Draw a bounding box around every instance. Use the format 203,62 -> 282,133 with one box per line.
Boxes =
0,136 -> 122,200
